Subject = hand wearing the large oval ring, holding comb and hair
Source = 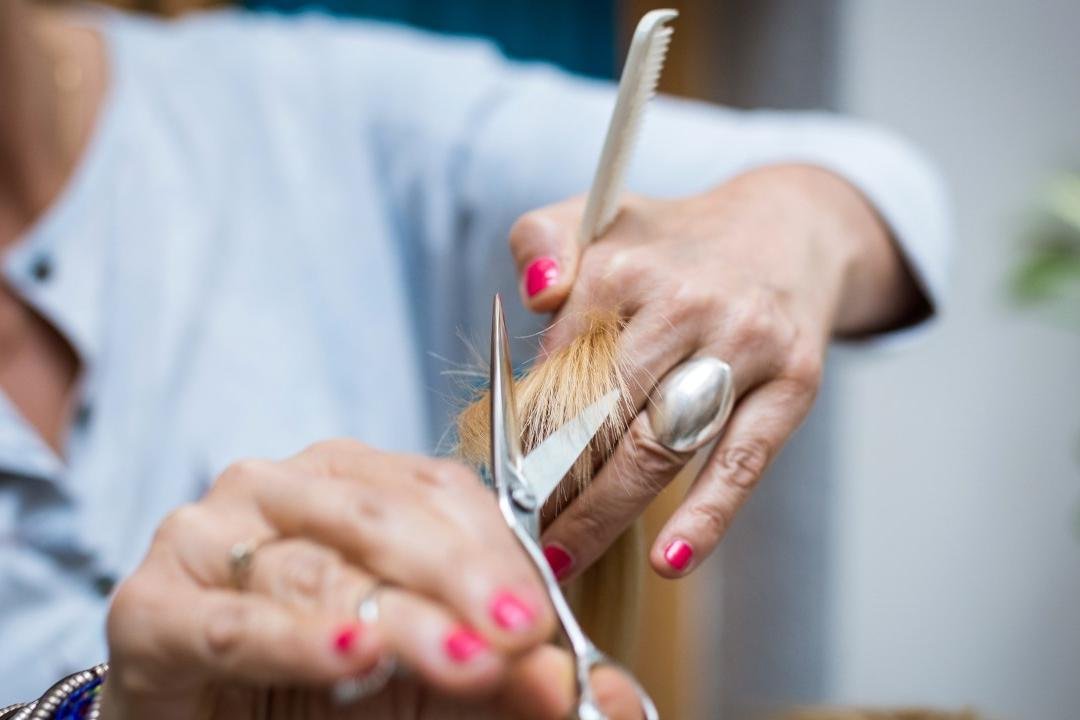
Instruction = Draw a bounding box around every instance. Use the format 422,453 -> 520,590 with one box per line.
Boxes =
510,166 -> 926,578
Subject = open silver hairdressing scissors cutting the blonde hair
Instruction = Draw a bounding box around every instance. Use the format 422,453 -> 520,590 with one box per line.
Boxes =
490,295 -> 660,720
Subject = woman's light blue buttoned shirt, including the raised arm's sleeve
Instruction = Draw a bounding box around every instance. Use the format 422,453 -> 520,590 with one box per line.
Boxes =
0,8 -> 945,705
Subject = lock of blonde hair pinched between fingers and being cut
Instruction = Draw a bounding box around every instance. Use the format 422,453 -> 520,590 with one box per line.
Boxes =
457,311 -> 643,663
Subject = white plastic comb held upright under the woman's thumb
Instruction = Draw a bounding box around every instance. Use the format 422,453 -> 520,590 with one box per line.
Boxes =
578,10 -> 678,247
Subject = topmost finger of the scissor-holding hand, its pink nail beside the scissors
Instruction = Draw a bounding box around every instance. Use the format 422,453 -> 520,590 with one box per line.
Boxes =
200,463 -> 555,652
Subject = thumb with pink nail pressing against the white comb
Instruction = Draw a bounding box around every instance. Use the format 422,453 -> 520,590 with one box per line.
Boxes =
510,198 -> 584,313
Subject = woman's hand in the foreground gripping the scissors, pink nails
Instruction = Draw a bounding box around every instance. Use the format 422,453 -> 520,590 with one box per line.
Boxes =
104,440 -> 638,720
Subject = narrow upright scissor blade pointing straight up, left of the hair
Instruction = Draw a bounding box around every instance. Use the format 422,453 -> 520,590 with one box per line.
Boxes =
490,295 -> 522,488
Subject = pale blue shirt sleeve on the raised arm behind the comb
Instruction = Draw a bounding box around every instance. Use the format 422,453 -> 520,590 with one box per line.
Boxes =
464,67 -> 948,338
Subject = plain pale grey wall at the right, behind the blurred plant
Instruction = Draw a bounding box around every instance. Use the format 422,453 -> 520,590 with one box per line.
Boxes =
831,0 -> 1080,720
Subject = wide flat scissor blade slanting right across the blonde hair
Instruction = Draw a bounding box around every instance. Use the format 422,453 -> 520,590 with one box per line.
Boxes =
522,390 -> 619,507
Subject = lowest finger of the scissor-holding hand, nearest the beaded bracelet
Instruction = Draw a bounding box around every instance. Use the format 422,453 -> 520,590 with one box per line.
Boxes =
109,575 -> 378,687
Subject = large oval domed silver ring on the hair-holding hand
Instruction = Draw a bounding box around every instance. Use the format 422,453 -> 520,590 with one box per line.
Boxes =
647,357 -> 735,452
